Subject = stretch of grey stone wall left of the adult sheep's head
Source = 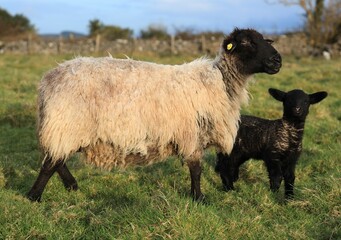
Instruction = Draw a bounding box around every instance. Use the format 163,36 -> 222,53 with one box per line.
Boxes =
0,38 -> 220,55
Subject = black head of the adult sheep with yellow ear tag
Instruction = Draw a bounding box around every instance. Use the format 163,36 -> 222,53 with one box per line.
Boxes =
222,28 -> 282,75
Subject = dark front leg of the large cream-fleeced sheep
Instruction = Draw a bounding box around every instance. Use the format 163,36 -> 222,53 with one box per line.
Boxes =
187,161 -> 204,201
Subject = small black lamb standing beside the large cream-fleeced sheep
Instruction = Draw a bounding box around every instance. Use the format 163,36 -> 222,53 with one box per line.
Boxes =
216,88 -> 327,199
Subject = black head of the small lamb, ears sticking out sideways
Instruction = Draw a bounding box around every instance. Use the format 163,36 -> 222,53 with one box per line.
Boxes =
269,88 -> 328,121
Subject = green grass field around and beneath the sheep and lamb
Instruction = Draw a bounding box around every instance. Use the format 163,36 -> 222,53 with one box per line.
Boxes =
0,55 -> 341,239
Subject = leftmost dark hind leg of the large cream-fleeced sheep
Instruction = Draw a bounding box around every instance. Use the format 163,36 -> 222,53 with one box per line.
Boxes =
27,157 -> 63,202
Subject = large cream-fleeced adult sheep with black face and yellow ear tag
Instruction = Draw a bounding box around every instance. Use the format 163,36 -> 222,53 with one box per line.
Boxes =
27,28 -> 281,201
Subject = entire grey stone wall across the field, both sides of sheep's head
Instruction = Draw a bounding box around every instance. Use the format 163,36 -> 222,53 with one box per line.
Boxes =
0,33 -> 341,57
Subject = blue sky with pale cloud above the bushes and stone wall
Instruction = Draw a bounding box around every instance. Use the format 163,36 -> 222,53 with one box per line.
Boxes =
0,0 -> 304,36
